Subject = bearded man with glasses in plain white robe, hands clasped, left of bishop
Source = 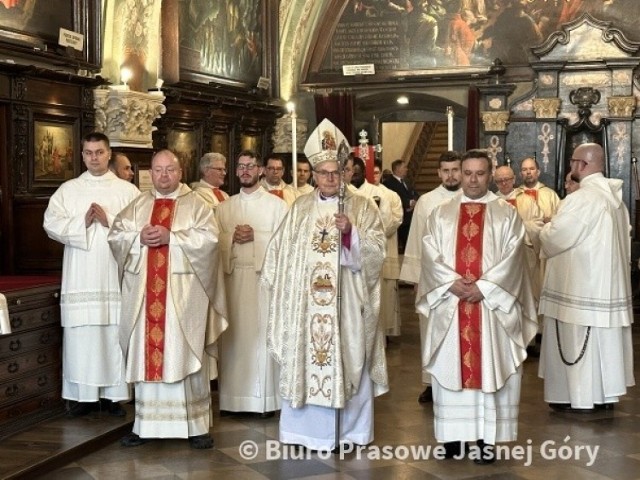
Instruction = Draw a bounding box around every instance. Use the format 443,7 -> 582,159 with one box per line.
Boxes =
216,150 -> 288,417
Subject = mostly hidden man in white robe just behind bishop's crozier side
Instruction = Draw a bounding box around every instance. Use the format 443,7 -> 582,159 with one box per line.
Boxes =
373,160 -> 404,337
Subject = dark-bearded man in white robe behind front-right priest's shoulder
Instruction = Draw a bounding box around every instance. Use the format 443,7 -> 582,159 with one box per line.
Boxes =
400,150 -> 460,403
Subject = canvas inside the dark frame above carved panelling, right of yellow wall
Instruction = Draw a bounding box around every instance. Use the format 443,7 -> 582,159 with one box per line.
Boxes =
179,0 -> 265,86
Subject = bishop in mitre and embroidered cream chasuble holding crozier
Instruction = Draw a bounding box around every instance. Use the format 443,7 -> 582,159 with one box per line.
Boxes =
262,119 -> 388,450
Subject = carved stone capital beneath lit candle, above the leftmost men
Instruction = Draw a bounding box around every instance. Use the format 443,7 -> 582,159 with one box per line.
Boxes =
93,87 -> 167,148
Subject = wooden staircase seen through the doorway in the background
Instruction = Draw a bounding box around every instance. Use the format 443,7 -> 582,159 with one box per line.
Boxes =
404,122 -> 447,194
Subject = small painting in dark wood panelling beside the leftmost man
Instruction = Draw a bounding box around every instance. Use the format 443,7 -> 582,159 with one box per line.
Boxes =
32,120 -> 77,184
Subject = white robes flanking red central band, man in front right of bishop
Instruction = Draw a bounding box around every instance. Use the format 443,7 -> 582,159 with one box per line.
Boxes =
416,192 -> 537,443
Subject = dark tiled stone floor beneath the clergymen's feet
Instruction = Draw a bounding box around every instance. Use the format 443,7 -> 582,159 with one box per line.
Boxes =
12,288 -> 640,480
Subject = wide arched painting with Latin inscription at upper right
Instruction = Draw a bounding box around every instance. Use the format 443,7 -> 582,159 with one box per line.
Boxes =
321,0 -> 640,74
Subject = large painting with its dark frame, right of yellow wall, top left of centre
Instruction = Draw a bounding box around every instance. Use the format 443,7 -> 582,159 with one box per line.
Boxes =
162,0 -> 277,92
